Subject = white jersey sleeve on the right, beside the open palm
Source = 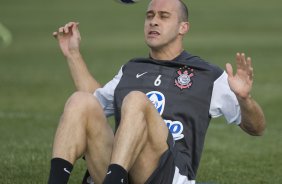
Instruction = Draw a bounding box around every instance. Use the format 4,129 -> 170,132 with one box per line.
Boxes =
209,71 -> 241,125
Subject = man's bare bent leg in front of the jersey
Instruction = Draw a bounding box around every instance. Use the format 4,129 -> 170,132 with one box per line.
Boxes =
106,91 -> 168,184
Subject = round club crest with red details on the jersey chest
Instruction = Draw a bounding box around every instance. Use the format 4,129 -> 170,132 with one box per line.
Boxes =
174,66 -> 194,90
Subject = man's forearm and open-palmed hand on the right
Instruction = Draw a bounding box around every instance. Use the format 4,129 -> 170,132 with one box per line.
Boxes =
226,53 -> 265,135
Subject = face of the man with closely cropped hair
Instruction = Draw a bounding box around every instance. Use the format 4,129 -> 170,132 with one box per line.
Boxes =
144,0 -> 184,50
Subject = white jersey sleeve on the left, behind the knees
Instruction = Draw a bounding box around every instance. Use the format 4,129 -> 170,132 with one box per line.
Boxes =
93,67 -> 123,117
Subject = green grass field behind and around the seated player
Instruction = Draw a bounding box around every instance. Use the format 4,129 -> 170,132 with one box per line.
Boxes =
0,0 -> 282,184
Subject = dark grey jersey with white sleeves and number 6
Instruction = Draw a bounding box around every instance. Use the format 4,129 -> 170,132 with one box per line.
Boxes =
94,51 -> 241,181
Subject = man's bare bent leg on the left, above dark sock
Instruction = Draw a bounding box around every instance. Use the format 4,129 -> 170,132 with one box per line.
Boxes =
49,92 -> 114,183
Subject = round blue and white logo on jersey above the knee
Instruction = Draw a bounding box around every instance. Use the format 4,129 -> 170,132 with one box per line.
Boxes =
146,91 -> 165,115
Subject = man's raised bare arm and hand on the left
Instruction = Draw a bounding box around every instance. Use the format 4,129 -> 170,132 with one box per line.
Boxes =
53,22 -> 101,93
